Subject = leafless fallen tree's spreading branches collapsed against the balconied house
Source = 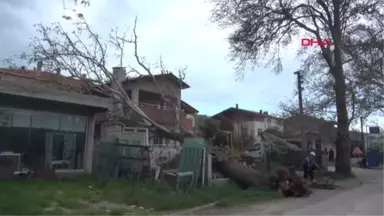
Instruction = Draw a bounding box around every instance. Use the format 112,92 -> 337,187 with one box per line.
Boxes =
22,14 -> 186,140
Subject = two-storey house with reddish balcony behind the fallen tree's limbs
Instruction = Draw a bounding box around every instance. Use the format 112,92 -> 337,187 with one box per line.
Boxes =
99,67 -> 198,145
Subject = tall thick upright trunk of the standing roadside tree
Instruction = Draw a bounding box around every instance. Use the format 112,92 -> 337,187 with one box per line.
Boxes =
332,0 -> 351,174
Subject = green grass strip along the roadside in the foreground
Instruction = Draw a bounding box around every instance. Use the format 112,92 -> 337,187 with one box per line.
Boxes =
0,178 -> 280,216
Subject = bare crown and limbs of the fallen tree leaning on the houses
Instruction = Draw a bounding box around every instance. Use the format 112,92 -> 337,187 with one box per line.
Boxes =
4,12 -> 190,141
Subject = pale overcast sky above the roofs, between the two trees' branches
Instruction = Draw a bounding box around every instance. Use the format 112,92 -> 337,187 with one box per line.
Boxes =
0,0 -> 380,126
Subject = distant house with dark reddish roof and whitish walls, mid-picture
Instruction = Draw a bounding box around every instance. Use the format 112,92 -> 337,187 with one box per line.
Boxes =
211,104 -> 284,142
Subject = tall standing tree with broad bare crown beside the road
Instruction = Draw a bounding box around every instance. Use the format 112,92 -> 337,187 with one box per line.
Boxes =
211,0 -> 384,173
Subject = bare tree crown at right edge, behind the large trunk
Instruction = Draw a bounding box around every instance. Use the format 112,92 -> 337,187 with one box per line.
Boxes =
345,29 -> 384,114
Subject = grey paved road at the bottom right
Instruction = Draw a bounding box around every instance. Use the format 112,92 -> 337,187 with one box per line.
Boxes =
182,169 -> 384,216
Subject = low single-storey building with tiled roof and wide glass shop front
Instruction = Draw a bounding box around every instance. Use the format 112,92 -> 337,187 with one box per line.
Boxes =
0,64 -> 110,172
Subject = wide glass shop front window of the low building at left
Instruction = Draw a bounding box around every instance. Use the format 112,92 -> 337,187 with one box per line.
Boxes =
0,108 -> 87,169
